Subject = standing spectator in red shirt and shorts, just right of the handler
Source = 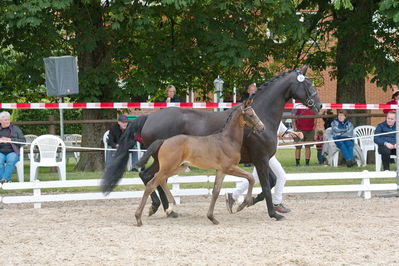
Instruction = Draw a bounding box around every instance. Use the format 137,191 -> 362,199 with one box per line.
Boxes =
294,109 -> 315,167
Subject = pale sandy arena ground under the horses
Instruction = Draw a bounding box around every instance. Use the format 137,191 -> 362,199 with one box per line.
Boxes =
0,193 -> 399,265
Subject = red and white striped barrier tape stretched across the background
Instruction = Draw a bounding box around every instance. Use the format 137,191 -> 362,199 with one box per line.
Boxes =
0,102 -> 399,110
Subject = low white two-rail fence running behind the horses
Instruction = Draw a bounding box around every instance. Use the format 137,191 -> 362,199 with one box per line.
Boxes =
0,171 -> 398,208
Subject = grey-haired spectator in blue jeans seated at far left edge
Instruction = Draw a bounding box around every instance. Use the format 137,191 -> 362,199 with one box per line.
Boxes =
0,111 -> 25,184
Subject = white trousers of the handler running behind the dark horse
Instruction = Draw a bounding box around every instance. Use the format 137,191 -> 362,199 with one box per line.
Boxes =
233,156 -> 286,204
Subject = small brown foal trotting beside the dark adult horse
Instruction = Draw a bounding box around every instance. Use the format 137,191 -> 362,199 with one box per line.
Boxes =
135,99 -> 265,226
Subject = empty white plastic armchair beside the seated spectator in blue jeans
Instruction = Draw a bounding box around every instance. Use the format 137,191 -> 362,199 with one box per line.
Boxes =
30,135 -> 66,182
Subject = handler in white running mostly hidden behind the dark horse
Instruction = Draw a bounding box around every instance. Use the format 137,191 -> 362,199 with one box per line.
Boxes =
226,122 -> 303,213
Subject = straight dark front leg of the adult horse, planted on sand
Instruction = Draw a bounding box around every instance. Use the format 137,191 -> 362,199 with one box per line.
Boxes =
254,159 -> 285,221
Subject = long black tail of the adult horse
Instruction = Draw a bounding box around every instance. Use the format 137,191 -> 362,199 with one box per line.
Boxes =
101,115 -> 147,194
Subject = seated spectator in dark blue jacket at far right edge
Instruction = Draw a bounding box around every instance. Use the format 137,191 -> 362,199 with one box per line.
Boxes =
374,111 -> 396,171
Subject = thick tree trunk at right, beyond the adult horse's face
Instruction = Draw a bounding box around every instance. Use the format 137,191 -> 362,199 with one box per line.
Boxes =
335,0 -> 374,126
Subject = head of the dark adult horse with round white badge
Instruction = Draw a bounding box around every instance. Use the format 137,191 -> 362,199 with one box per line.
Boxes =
291,65 -> 321,113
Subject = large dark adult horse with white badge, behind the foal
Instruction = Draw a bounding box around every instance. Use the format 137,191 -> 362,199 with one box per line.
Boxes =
101,66 -> 321,220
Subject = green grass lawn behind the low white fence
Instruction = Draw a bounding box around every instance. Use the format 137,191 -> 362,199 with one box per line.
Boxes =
0,149 -> 396,194
